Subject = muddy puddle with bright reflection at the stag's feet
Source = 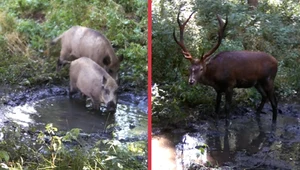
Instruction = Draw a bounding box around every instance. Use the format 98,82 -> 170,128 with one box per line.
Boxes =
152,102 -> 300,170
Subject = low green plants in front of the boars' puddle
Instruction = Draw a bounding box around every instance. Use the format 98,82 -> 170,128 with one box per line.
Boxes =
0,124 -> 147,170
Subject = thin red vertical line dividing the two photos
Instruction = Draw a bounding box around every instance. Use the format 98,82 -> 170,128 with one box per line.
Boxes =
148,0 -> 152,170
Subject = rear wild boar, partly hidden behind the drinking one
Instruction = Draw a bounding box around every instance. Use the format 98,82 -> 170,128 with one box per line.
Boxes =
51,26 -> 123,80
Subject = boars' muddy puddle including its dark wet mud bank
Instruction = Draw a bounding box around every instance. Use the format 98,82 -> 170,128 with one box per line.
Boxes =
0,87 -> 148,142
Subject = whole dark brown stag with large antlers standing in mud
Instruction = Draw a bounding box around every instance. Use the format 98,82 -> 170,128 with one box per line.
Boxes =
173,11 -> 277,122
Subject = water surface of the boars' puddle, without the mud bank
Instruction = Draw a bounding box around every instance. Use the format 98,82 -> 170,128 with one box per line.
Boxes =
0,96 -> 147,139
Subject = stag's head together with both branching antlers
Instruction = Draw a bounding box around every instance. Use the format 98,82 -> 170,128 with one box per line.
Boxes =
173,10 -> 228,85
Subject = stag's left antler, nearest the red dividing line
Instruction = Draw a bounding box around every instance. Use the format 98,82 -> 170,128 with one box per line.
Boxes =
173,9 -> 196,60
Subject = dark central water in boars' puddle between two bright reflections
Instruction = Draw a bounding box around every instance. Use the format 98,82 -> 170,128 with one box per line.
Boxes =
31,97 -> 114,133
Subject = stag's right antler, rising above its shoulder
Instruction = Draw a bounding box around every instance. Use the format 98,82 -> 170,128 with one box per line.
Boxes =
202,14 -> 228,60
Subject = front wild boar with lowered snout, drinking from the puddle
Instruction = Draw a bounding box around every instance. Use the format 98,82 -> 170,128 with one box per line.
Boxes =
69,57 -> 118,111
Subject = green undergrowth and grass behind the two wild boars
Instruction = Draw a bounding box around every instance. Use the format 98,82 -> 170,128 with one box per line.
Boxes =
0,0 -> 147,88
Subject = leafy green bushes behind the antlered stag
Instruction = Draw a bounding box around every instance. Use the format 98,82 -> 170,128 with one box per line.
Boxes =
152,0 -> 300,117
